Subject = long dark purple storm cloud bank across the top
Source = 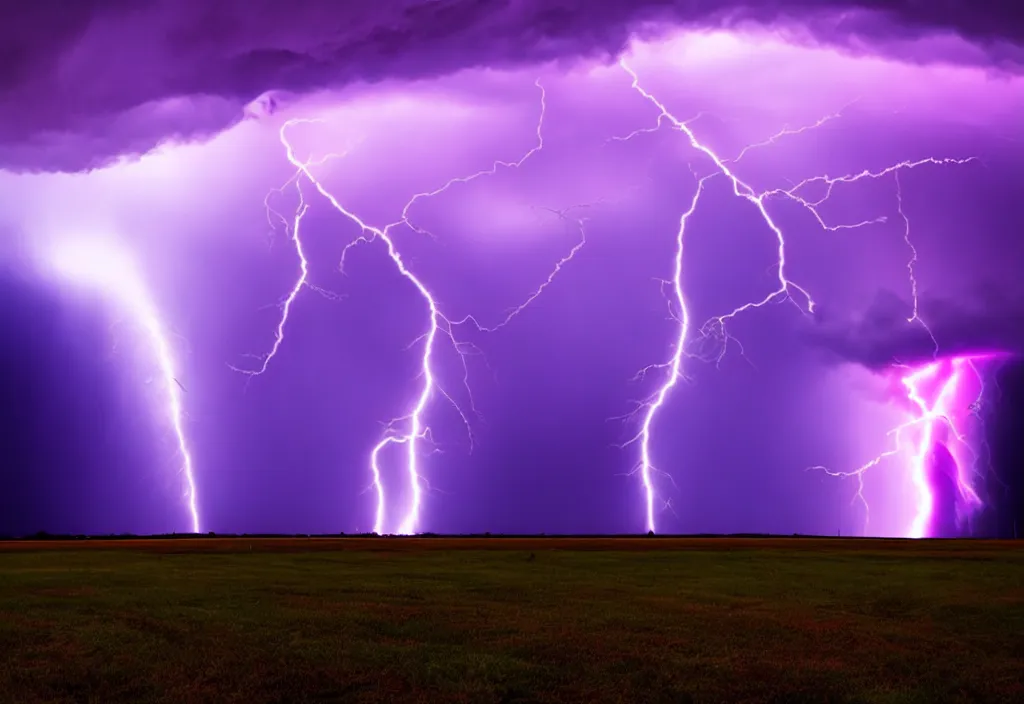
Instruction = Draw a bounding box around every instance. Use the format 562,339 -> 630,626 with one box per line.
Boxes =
0,0 -> 1024,171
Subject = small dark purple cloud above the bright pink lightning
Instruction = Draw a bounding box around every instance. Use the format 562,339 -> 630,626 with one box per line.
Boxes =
807,291 -> 1024,369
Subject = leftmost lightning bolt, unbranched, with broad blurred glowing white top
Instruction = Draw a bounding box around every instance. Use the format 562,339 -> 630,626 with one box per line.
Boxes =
47,237 -> 200,533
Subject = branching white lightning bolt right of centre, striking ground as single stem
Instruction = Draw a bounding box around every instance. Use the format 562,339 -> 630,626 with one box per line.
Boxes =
618,59 -> 974,531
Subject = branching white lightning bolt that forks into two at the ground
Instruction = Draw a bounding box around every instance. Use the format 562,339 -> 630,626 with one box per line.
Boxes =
250,81 -> 598,534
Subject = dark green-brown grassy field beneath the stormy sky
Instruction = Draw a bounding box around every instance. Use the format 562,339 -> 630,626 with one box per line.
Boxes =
0,538 -> 1024,704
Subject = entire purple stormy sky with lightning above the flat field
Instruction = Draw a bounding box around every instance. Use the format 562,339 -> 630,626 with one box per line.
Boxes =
0,0 -> 1024,537
